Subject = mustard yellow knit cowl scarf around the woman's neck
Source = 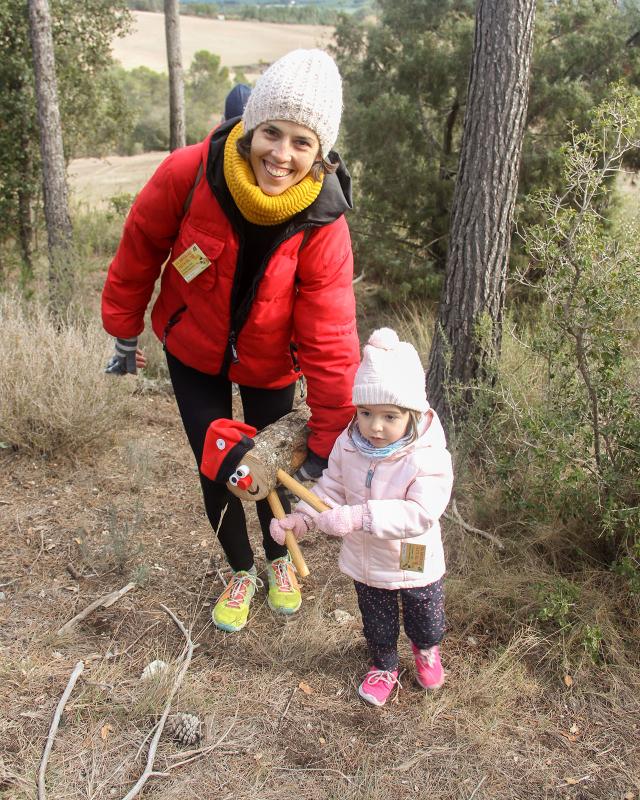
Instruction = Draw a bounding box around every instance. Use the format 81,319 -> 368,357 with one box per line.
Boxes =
224,122 -> 322,225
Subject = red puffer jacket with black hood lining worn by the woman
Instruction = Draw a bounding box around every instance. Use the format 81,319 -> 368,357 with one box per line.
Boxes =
102,125 -> 359,457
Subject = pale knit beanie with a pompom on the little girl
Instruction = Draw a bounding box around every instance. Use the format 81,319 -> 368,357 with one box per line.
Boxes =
352,328 -> 429,413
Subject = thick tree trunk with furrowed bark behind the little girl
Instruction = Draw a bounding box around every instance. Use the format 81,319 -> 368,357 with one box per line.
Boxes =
427,0 -> 535,429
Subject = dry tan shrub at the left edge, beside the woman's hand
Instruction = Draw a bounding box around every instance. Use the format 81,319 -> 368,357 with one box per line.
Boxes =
0,294 -> 132,455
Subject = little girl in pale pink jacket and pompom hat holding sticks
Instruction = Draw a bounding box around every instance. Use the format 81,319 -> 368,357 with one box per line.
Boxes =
270,328 -> 453,706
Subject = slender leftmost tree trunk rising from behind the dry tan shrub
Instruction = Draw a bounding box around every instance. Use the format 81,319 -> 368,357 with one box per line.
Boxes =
28,0 -> 73,318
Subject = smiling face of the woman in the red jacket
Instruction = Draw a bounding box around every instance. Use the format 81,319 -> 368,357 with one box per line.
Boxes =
249,119 -> 321,196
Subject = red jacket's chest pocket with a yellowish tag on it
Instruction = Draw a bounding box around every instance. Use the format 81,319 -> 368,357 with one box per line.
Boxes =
170,222 -> 225,293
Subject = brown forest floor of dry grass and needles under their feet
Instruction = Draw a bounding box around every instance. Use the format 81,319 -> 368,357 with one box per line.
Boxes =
0,378 -> 640,800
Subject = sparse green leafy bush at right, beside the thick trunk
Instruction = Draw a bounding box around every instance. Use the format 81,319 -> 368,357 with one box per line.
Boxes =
460,88 -> 640,588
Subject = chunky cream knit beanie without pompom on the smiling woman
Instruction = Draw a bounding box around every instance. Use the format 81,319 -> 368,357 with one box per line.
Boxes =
242,50 -> 342,158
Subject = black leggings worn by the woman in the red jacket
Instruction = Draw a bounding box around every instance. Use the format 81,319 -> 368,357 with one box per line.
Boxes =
166,352 -> 295,570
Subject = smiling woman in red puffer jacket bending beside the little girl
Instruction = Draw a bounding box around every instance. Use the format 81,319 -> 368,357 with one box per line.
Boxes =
102,50 -> 359,631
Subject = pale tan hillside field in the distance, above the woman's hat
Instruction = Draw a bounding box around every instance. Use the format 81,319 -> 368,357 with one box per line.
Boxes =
112,11 -> 333,76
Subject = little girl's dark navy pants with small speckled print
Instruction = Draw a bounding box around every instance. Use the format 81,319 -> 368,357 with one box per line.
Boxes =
354,578 -> 445,671
